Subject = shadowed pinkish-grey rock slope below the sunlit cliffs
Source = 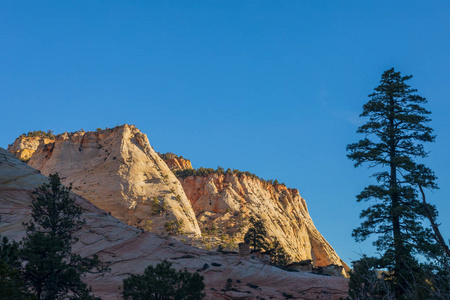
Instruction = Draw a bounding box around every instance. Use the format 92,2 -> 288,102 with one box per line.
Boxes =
0,148 -> 348,300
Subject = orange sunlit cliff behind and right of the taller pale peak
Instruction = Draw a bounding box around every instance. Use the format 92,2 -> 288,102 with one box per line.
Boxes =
179,172 -> 349,273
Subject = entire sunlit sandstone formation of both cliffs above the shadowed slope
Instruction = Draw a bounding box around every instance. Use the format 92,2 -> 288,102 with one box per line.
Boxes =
9,125 -> 348,275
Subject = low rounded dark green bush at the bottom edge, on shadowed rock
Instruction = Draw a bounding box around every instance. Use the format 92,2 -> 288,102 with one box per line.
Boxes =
122,260 -> 205,300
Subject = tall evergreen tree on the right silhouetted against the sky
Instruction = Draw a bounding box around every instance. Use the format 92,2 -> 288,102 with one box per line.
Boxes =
347,68 -> 437,299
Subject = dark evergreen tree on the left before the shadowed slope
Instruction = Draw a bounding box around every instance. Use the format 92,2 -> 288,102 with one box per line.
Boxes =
21,174 -> 104,300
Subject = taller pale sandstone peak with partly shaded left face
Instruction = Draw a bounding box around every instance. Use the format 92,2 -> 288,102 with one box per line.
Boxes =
23,125 -> 200,236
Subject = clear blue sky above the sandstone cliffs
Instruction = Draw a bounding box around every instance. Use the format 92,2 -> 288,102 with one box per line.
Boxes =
0,0 -> 450,262
